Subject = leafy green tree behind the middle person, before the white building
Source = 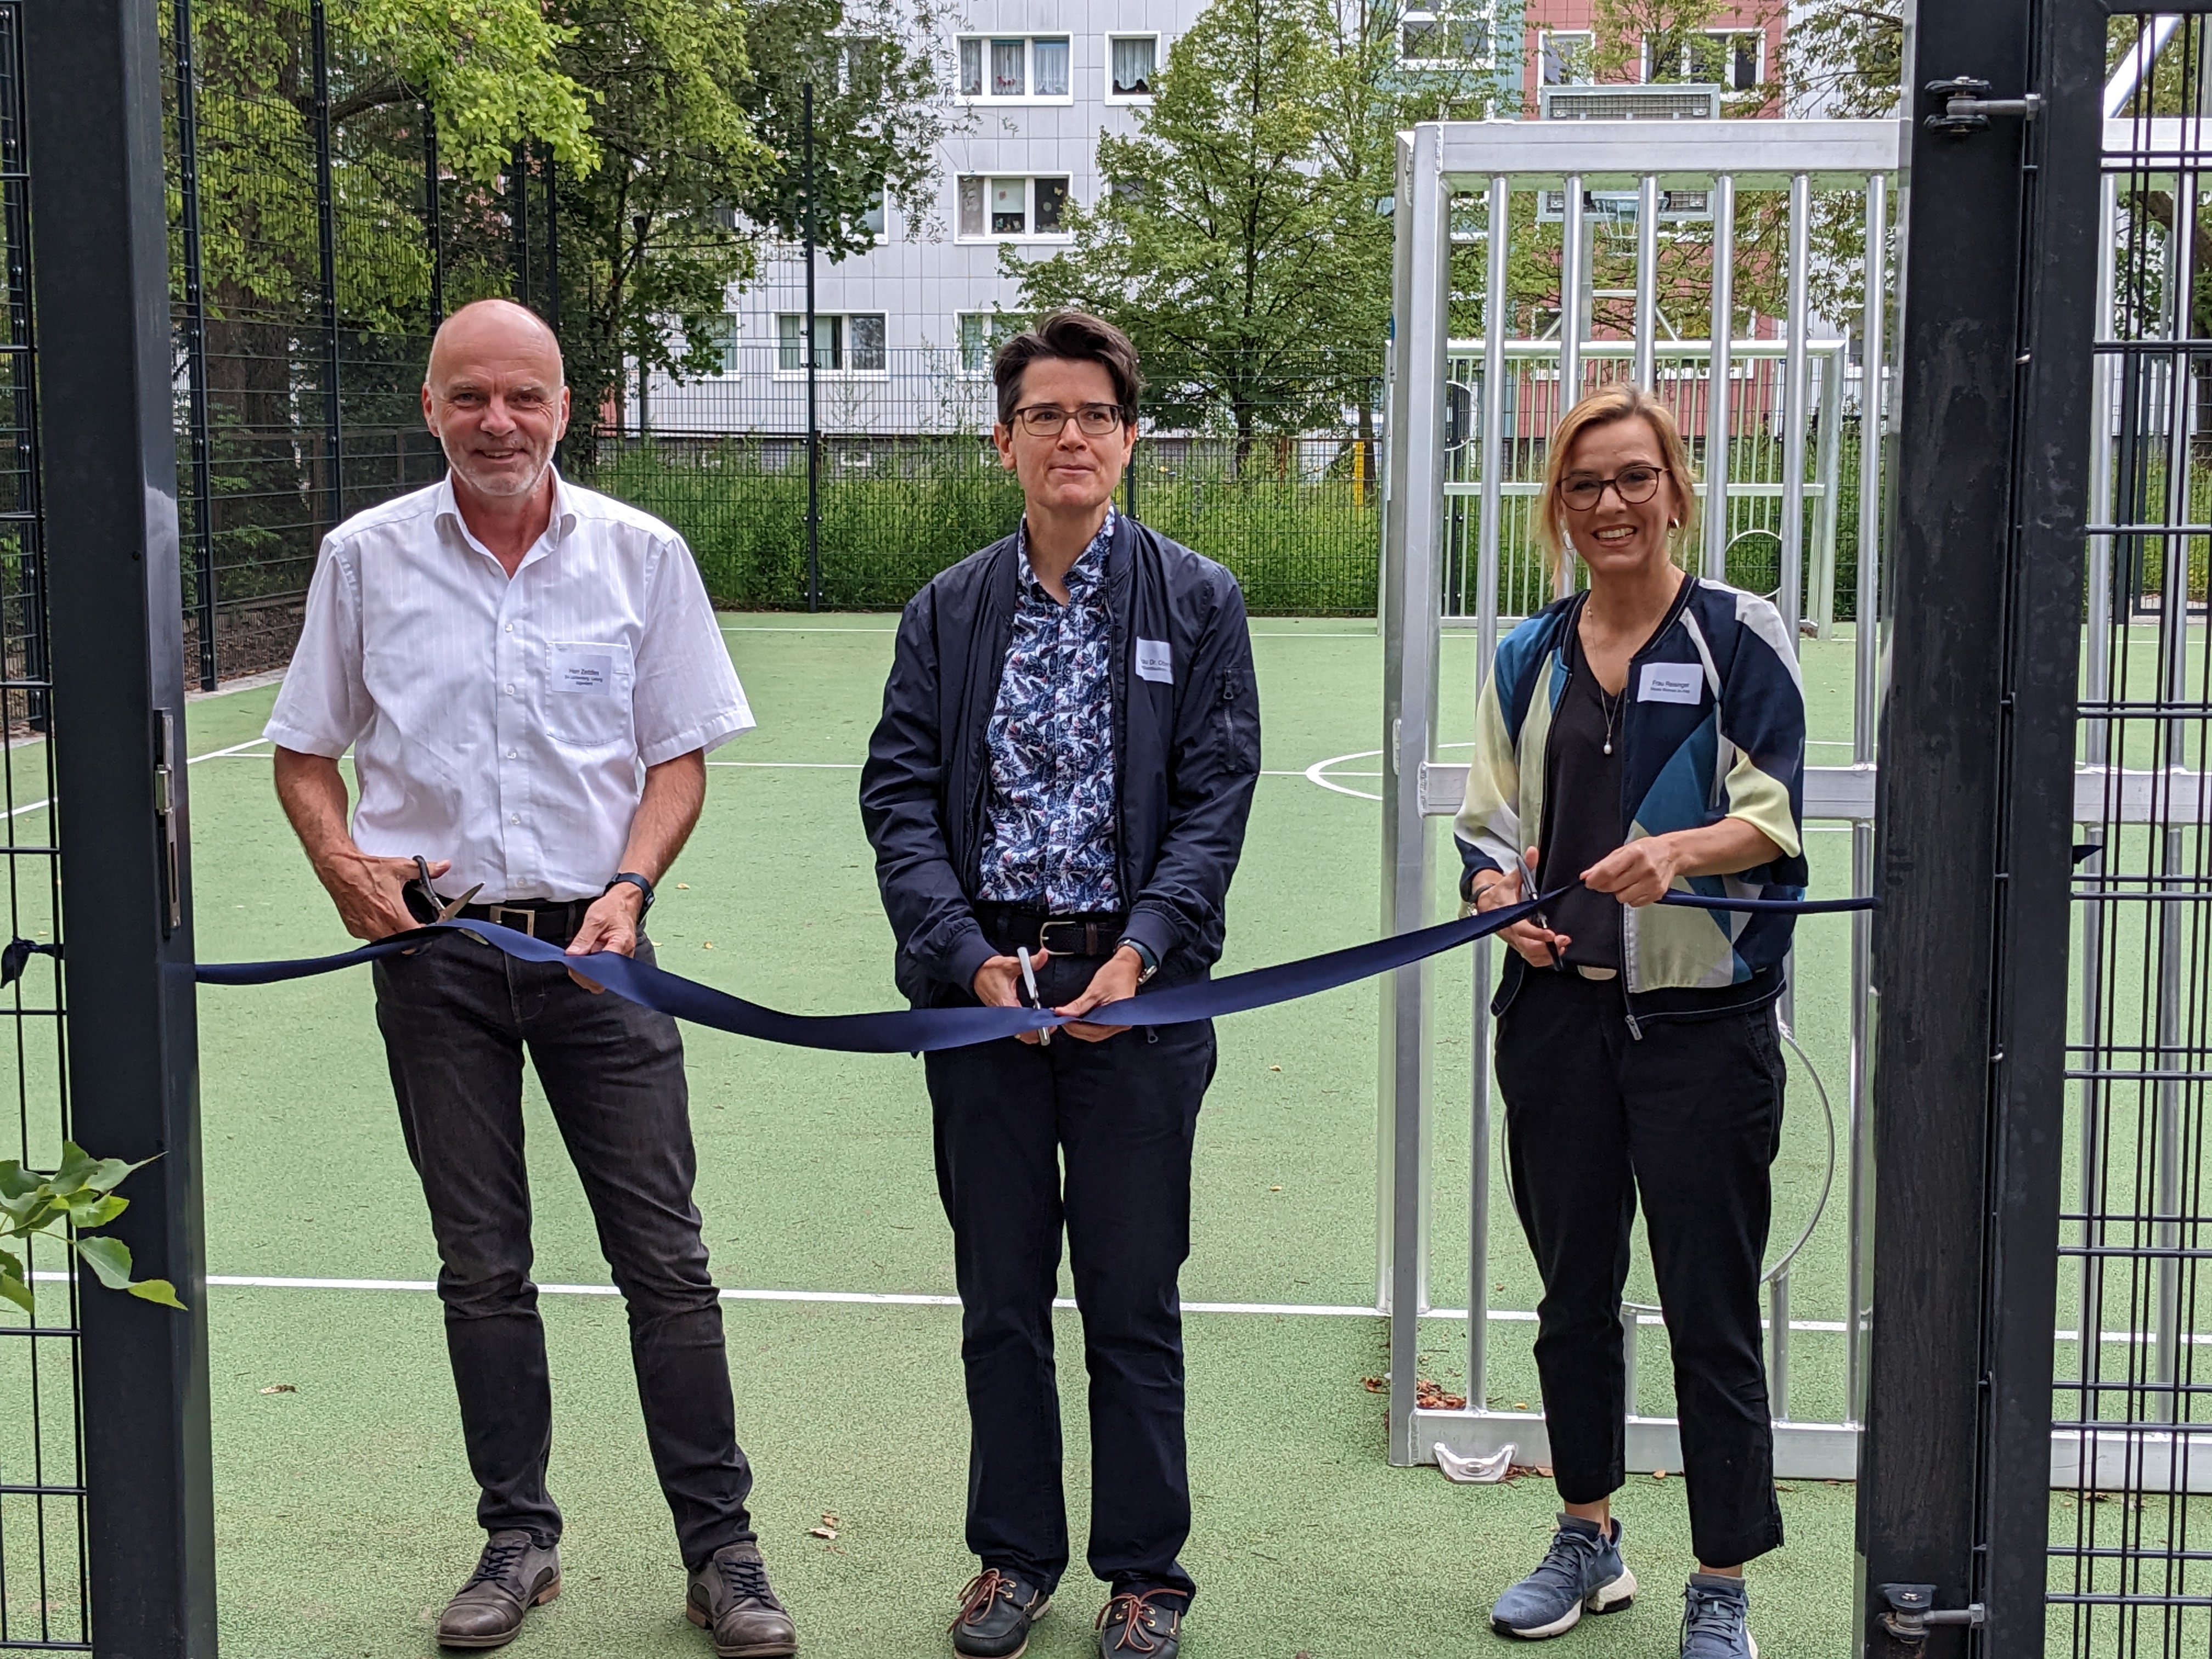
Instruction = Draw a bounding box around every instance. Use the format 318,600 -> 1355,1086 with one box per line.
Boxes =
1002,0 -> 1493,465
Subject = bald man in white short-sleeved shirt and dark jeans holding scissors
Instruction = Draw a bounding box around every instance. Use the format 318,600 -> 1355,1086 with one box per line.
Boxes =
266,301 -> 799,1659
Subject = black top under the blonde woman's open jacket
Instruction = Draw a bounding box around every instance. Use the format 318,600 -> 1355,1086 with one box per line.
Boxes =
1535,606 -> 1628,969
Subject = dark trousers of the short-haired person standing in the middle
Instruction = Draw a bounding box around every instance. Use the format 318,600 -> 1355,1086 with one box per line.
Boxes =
924,956 -> 1215,1595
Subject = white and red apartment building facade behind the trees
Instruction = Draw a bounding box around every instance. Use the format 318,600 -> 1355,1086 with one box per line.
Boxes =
633,0 -> 1783,433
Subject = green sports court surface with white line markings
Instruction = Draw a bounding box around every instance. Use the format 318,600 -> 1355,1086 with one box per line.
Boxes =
163,615 -> 1854,1659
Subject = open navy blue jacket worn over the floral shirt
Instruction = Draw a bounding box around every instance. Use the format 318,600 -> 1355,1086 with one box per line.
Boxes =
860,515 -> 1259,1007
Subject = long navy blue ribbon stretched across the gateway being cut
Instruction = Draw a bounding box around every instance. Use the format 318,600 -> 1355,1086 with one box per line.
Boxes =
195,887 -> 1874,1055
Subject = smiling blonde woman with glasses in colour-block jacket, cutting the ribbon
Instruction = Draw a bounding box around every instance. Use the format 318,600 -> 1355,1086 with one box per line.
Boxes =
1455,387 -> 1805,1659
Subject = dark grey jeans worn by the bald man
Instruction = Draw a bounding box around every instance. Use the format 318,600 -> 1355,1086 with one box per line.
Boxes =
376,936 -> 752,1566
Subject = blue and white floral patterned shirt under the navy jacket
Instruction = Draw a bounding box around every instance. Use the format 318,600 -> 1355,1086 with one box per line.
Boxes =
982,506 -> 1121,916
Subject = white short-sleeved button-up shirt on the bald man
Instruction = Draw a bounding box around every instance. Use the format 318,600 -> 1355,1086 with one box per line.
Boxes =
266,478 -> 752,902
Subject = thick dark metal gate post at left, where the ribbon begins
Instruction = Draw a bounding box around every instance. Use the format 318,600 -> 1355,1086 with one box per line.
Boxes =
22,0 -> 215,1659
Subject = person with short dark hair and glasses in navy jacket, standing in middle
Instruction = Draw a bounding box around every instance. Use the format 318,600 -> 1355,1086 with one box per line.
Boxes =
860,312 -> 1259,1659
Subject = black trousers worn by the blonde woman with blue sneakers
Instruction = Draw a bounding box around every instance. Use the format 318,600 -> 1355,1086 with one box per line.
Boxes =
1498,971 -> 1783,1566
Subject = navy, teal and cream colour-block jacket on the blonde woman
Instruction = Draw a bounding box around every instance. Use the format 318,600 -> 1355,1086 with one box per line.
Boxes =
1453,577 -> 1805,997
